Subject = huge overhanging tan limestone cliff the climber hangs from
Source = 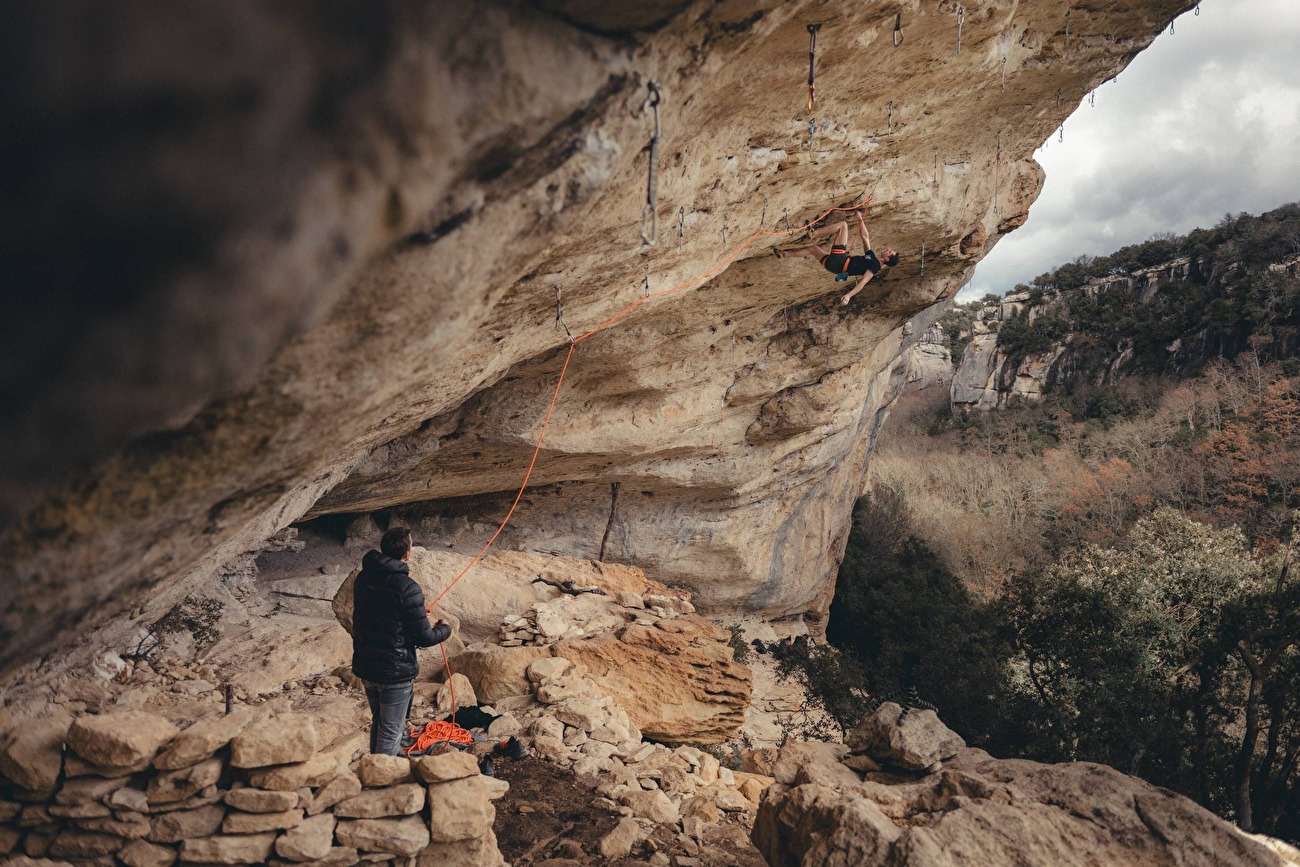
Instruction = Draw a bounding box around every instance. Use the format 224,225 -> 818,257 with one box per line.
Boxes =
0,0 -> 1192,669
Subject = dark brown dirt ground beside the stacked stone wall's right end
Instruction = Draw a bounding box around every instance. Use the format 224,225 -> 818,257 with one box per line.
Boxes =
493,758 -> 766,867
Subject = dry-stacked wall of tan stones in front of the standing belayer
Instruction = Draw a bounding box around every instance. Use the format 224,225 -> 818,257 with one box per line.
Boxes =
0,708 -> 508,867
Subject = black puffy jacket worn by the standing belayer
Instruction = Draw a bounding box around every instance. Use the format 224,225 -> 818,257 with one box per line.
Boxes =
352,551 -> 451,684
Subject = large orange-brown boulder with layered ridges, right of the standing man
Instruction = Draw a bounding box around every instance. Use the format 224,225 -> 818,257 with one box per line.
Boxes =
551,615 -> 751,744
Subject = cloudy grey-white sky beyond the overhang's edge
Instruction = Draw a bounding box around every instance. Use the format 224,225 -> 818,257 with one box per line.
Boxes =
958,0 -> 1300,300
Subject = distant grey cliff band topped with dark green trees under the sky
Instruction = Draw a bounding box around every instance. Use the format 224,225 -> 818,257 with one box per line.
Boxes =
935,205 -> 1300,409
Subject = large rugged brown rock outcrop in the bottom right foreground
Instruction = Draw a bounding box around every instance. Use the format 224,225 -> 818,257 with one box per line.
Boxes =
753,706 -> 1278,867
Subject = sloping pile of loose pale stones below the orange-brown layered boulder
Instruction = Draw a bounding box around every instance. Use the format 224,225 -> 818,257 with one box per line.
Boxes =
506,656 -> 772,859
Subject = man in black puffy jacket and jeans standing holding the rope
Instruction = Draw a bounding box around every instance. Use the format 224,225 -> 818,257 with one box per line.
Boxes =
352,528 -> 451,755
